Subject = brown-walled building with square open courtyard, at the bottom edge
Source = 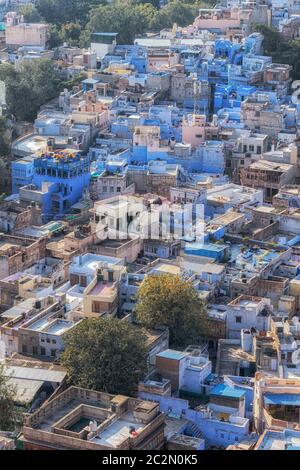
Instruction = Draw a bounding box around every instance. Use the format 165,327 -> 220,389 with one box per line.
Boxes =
22,387 -> 165,450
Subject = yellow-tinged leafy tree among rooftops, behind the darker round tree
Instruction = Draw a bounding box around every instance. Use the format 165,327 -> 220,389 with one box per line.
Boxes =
136,274 -> 209,347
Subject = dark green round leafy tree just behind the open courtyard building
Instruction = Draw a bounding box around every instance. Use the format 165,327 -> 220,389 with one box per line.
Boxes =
62,318 -> 147,394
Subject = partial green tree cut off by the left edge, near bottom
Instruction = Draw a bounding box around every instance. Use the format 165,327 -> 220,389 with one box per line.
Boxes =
0,364 -> 17,431
